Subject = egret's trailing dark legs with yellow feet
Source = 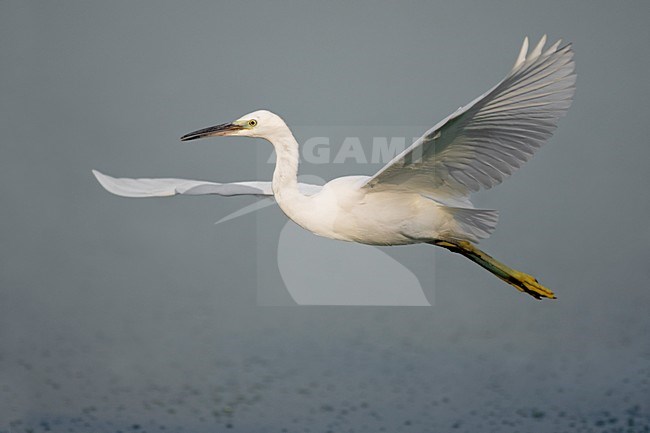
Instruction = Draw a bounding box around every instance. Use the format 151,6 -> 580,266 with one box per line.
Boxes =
431,240 -> 556,299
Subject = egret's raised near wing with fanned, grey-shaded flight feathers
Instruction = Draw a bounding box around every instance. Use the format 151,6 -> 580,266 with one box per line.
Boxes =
362,36 -> 576,197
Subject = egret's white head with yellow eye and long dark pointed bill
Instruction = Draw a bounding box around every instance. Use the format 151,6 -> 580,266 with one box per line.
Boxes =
181,110 -> 287,141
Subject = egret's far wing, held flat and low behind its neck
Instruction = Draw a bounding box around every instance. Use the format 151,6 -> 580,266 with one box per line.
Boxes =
93,170 -> 322,197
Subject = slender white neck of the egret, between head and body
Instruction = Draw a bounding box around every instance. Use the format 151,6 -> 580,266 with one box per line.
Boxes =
268,126 -> 309,219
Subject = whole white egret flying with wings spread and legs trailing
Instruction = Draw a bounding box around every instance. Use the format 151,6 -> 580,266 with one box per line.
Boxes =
93,36 -> 576,299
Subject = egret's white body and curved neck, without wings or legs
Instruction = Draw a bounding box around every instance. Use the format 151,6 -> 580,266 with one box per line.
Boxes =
253,124 -> 476,245
